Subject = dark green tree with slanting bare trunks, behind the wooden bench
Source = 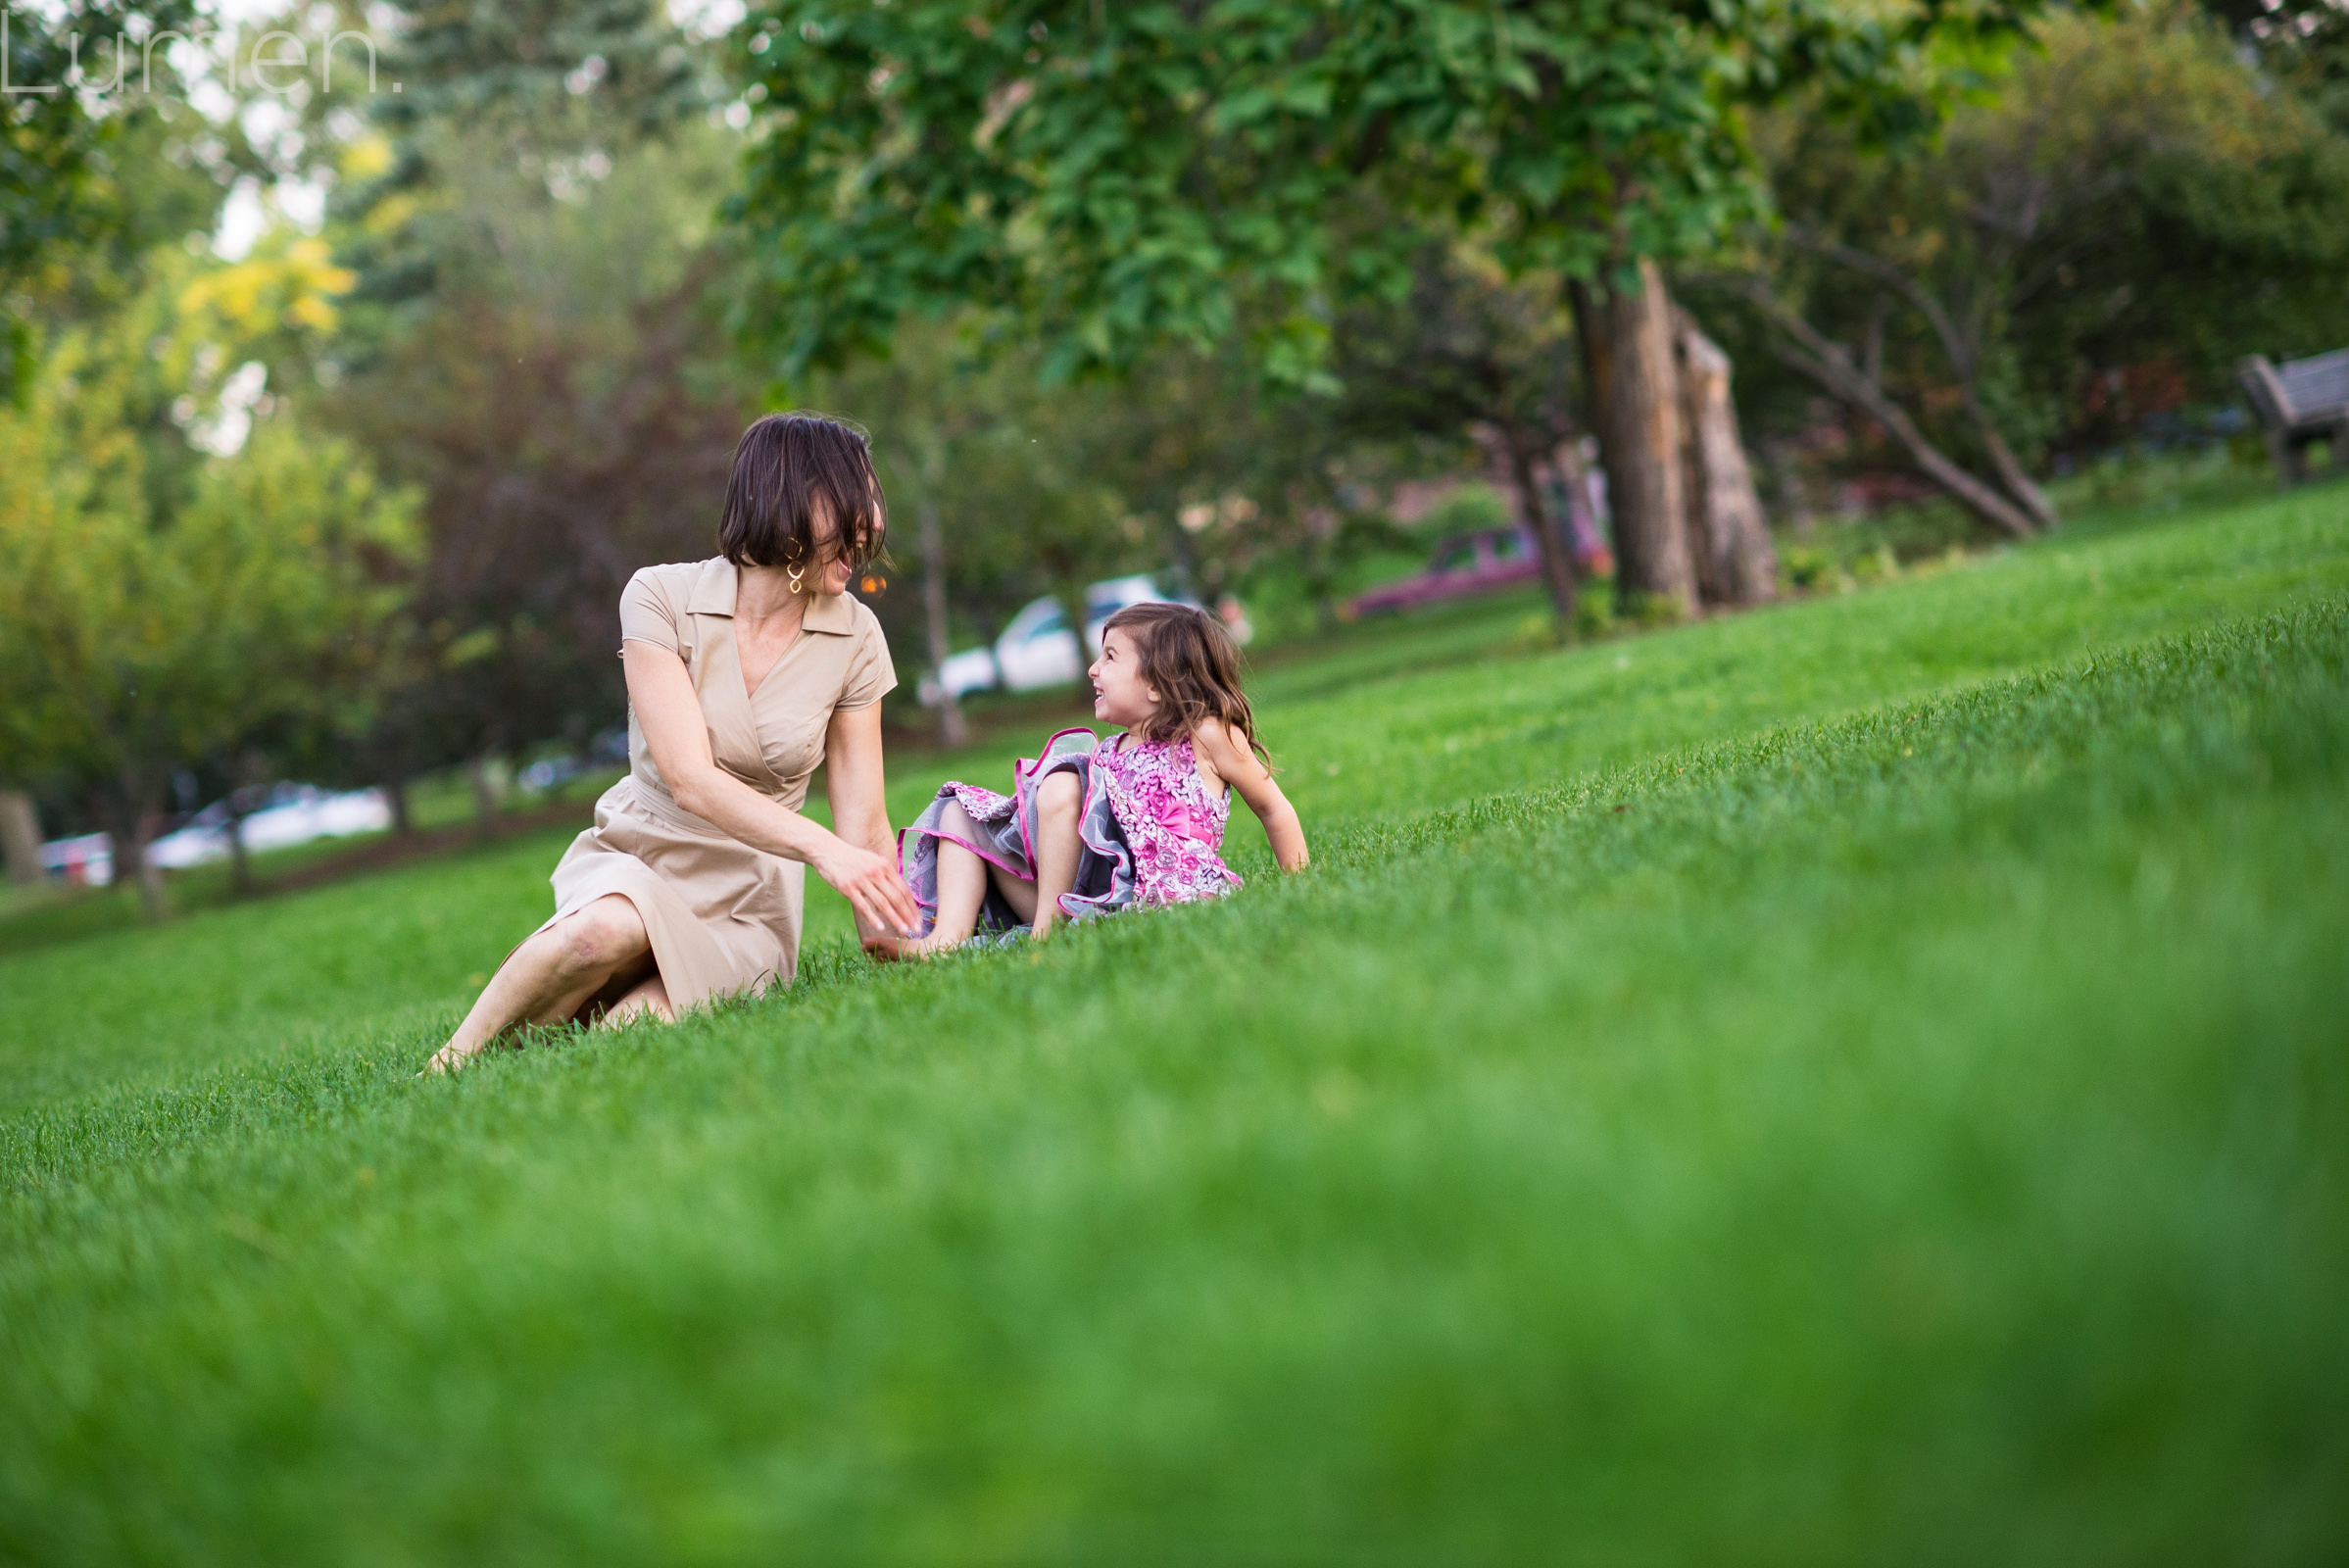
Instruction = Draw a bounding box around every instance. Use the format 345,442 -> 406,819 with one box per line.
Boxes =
1720,7 -> 2349,535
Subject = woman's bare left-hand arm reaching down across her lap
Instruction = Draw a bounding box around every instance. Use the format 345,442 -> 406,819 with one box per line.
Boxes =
620,638 -> 921,934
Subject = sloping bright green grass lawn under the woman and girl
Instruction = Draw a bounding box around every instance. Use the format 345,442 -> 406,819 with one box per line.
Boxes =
0,493 -> 2349,1563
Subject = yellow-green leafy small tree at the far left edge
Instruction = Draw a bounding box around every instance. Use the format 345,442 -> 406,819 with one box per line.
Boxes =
0,293 -> 414,918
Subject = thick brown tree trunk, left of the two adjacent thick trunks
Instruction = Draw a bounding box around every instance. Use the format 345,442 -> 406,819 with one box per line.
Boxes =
1574,258 -> 1696,615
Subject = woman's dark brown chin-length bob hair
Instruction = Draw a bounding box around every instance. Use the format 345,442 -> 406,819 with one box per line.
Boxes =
718,411 -> 888,568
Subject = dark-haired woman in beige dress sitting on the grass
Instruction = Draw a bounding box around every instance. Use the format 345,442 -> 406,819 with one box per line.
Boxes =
430,414 -> 921,1073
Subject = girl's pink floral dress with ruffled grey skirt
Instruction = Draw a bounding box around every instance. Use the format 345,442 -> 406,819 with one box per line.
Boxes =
898,730 -> 1241,934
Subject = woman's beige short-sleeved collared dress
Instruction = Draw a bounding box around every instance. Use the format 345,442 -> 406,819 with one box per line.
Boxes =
538,559 -> 898,1009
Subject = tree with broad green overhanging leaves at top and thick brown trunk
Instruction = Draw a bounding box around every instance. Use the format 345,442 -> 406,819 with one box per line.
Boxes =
738,0 -> 2028,601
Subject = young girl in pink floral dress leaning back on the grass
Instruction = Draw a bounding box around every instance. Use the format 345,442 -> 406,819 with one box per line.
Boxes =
871,604 -> 1306,957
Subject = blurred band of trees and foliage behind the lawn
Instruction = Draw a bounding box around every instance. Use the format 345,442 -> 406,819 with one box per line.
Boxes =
0,0 -> 2349,919
